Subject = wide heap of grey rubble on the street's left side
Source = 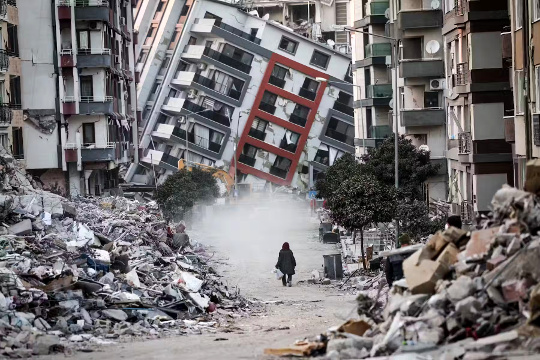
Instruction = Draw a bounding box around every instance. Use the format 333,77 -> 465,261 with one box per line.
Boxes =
0,147 -> 258,358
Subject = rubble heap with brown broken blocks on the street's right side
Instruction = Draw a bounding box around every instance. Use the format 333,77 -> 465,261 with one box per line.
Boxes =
267,186 -> 540,360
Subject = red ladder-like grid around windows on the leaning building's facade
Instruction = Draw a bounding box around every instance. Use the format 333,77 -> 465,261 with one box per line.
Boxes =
230,53 -> 329,185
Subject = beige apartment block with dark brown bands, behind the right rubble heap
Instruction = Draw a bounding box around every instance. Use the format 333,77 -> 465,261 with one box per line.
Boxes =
443,0 -> 514,222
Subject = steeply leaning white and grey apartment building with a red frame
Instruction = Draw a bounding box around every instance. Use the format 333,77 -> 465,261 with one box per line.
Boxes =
127,0 -> 354,189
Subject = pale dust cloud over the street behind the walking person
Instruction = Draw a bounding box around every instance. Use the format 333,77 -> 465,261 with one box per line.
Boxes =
192,197 -> 335,297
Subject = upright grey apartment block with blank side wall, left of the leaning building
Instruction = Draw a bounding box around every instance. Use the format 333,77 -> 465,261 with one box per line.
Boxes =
18,0 -> 137,196
